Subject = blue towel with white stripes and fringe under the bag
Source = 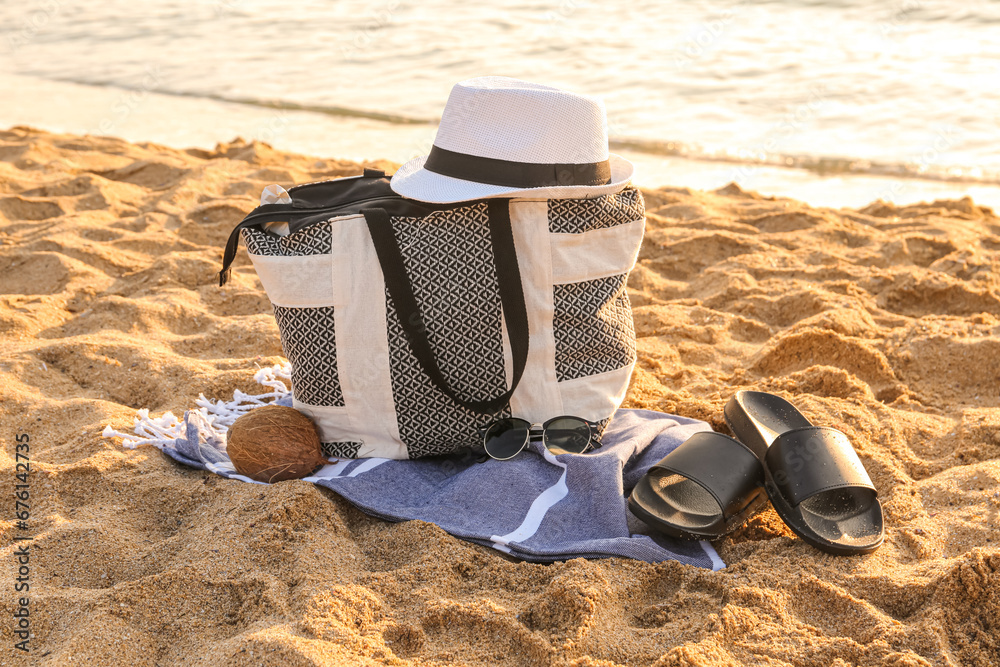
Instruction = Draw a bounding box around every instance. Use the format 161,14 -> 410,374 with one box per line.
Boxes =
104,365 -> 724,570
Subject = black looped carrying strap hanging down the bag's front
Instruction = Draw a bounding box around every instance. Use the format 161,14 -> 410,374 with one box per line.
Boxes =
361,199 -> 528,414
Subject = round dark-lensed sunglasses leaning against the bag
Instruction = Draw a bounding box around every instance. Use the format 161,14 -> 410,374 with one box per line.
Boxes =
479,416 -> 600,461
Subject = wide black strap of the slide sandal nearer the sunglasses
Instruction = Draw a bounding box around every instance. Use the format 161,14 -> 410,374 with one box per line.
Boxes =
650,431 -> 764,519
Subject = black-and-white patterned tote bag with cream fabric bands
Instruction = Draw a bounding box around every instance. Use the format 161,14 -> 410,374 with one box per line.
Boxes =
220,170 -> 645,459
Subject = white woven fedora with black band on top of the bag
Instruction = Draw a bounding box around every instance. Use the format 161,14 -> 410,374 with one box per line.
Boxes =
392,76 -> 635,204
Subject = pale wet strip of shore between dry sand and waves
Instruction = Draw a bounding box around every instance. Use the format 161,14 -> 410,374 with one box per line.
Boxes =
0,75 -> 1000,209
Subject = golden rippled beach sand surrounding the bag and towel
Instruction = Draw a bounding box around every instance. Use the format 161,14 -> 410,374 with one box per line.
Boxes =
0,127 -> 1000,667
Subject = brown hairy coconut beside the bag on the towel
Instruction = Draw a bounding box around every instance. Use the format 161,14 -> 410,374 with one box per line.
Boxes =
226,405 -> 327,483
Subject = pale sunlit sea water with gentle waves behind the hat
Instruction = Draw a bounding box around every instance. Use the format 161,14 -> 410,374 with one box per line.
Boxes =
0,0 -> 1000,206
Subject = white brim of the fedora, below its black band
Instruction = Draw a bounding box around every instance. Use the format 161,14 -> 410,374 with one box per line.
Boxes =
390,153 -> 635,204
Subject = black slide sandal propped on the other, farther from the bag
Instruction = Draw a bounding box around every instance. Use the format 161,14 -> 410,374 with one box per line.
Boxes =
724,391 -> 885,556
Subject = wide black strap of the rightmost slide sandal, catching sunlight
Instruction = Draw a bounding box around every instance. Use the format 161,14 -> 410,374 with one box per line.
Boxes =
764,426 -> 876,506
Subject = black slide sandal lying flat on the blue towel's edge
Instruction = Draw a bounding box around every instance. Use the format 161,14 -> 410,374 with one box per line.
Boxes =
628,431 -> 767,540
